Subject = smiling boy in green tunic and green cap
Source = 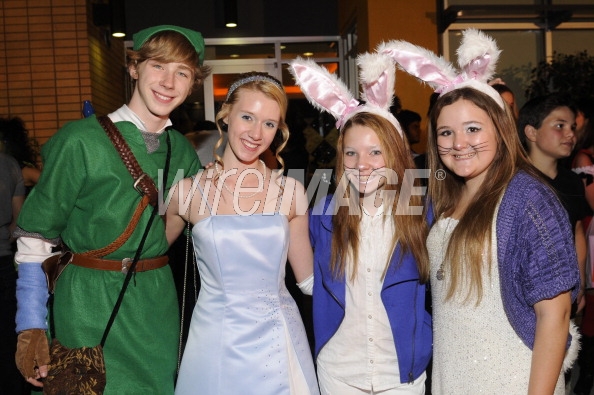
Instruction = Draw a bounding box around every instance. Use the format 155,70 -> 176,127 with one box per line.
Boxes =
15,25 -> 210,394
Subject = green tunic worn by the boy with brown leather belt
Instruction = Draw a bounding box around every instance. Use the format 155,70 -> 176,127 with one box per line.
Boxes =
18,116 -> 200,395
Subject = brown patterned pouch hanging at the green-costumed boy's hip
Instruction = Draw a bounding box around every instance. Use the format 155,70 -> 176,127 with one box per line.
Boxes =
43,339 -> 106,395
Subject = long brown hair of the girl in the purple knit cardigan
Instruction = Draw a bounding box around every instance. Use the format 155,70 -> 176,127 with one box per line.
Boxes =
427,88 -> 541,304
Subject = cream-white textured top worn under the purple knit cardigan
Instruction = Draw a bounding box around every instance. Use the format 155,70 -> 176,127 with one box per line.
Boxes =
427,215 -> 565,395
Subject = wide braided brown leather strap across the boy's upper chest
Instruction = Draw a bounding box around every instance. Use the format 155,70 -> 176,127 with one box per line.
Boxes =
97,115 -> 158,207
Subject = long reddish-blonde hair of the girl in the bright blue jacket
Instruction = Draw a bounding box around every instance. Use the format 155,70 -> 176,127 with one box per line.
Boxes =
330,112 -> 429,282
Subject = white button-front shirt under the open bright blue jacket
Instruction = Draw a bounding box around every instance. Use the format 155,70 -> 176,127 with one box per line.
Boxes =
317,206 -> 408,391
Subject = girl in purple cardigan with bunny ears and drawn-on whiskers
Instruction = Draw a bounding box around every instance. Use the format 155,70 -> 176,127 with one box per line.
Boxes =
378,29 -> 580,395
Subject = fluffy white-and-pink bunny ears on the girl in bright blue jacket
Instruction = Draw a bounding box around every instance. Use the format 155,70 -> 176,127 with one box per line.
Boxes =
289,53 -> 402,136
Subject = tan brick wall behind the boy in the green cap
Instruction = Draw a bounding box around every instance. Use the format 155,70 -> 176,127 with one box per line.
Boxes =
0,0 -> 126,144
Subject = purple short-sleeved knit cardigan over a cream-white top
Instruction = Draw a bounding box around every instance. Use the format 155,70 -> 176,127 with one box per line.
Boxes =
497,171 -> 580,349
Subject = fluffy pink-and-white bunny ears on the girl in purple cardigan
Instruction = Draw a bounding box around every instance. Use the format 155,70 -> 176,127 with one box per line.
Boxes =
377,29 -> 505,108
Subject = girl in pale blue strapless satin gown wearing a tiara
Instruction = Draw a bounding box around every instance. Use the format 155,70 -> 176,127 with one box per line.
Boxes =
167,73 -> 319,395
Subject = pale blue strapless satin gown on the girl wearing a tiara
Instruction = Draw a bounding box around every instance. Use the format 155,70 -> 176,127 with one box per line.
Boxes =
175,189 -> 319,395
